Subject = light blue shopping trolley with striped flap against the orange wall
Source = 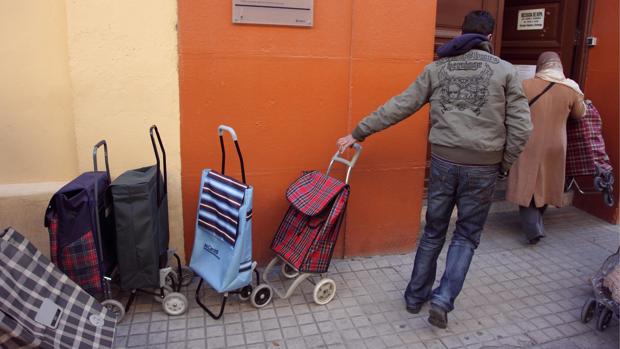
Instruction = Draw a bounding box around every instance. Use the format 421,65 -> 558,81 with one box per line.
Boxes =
189,125 -> 272,320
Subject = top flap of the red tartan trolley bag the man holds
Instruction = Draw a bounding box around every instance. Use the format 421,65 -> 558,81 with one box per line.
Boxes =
286,171 -> 345,216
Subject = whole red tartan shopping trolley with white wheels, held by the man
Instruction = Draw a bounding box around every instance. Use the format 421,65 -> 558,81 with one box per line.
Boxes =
263,144 -> 362,305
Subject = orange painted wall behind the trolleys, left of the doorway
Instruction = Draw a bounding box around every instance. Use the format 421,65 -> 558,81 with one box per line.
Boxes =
179,0 -> 435,262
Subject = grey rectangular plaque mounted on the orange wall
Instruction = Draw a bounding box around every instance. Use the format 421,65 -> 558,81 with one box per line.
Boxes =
233,0 -> 314,27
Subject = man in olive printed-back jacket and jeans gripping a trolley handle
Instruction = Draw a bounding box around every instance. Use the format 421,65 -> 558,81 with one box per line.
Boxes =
337,11 -> 532,328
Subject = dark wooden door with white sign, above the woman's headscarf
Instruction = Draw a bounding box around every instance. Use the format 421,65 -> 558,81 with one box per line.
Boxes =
501,0 -> 581,79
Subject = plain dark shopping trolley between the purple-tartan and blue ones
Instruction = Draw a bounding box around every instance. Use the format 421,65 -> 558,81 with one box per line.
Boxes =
110,125 -> 192,315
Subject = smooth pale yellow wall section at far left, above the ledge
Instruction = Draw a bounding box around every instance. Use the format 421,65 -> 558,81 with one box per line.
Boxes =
0,0 -> 77,184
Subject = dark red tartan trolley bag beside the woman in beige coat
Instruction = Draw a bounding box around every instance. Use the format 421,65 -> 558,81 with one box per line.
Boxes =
566,103 -> 612,177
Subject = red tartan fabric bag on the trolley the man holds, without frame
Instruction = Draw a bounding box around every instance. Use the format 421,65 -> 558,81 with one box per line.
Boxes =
271,171 -> 349,273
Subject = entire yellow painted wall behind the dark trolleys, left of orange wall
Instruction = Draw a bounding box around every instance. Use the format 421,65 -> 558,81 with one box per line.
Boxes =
0,0 -> 183,255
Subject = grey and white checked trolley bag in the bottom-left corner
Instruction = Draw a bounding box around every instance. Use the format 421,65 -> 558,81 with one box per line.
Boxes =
0,228 -> 116,349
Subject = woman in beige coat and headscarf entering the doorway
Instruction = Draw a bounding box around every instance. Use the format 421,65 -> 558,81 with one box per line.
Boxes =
506,52 -> 586,244
